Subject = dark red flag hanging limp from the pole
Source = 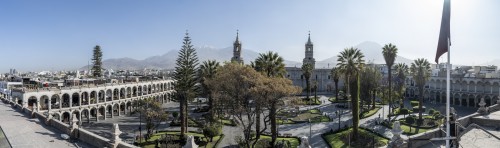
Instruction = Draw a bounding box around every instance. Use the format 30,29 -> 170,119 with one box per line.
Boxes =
435,0 -> 451,63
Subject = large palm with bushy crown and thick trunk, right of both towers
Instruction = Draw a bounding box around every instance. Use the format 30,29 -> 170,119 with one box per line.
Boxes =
337,47 -> 365,140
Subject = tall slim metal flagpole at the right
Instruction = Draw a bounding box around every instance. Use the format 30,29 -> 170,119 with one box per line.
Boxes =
446,37 -> 451,148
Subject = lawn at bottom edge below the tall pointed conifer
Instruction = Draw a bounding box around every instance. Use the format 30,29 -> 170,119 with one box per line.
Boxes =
139,132 -> 221,148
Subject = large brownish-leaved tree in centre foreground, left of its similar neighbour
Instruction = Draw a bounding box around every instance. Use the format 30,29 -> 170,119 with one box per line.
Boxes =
207,63 -> 265,148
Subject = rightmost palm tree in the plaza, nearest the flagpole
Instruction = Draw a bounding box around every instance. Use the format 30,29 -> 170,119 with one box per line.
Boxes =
410,58 -> 431,121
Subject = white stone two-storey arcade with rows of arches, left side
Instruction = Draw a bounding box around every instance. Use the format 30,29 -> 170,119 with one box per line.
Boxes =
7,80 -> 174,123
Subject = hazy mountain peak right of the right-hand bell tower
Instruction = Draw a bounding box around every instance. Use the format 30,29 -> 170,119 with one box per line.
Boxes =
316,41 -> 413,67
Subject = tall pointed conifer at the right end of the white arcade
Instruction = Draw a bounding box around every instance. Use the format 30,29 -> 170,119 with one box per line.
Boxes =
174,32 -> 198,136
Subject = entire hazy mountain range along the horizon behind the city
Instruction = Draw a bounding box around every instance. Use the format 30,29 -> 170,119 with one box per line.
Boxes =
81,41 -> 414,70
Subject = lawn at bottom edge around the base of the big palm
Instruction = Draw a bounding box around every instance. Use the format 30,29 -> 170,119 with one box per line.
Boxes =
323,128 -> 389,148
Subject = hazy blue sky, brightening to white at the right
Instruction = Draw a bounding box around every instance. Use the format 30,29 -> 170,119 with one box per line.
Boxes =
0,0 -> 500,72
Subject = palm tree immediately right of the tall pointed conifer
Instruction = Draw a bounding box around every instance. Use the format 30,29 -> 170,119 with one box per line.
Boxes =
199,60 -> 220,119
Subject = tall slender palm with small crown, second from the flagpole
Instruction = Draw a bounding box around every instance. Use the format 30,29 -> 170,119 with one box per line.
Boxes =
382,43 -> 398,121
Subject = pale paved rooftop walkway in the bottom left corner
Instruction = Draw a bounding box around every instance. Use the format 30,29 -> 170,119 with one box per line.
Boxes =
0,102 -> 88,148
